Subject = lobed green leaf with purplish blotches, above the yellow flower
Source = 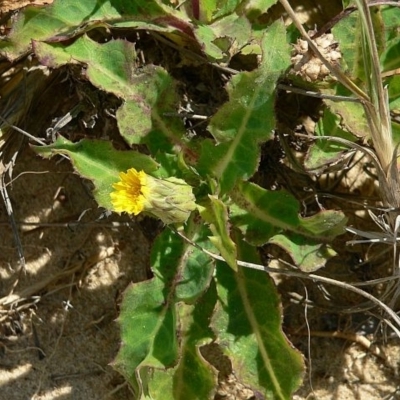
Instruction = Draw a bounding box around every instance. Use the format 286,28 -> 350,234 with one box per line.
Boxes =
35,36 -> 185,154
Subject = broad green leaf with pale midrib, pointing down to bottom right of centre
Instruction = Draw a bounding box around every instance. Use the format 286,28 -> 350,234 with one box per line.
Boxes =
212,239 -> 304,400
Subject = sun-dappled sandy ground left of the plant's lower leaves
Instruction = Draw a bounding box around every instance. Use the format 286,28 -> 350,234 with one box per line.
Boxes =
0,148 -> 149,400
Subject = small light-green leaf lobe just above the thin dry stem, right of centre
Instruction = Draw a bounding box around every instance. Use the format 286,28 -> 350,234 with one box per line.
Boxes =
269,232 -> 336,273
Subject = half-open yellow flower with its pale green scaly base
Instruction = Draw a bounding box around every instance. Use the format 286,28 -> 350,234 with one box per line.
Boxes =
110,168 -> 196,224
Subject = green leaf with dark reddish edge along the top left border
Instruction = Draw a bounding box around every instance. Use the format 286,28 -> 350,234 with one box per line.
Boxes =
0,0 -> 190,59
